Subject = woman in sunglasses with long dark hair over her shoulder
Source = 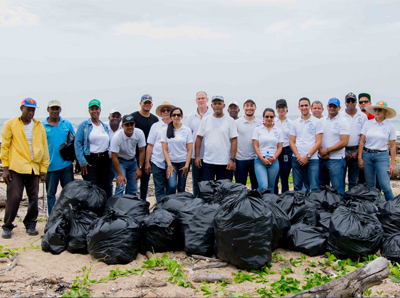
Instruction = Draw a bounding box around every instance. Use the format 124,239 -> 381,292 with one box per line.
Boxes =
161,107 -> 193,194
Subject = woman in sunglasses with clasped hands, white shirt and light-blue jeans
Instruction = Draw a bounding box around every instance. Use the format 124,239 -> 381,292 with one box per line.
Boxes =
252,108 -> 283,193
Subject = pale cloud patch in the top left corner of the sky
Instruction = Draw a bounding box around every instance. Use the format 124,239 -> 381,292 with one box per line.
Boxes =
0,0 -> 39,27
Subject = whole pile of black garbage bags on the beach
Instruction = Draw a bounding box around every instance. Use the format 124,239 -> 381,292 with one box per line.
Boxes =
42,180 -> 400,270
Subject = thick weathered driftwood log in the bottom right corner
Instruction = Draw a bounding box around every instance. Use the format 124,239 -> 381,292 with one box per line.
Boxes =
287,257 -> 389,298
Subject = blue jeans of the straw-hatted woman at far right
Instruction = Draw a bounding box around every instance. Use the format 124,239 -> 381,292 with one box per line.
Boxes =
362,151 -> 393,201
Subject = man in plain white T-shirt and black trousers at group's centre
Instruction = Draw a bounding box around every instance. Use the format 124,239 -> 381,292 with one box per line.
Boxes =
195,95 -> 238,181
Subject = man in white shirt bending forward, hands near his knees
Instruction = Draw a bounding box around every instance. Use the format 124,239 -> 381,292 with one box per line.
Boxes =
110,115 -> 146,196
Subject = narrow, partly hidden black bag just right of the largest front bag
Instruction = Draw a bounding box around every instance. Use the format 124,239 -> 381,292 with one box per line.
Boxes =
262,199 -> 291,250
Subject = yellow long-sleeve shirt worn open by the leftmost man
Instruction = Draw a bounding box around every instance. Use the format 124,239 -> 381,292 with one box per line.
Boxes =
0,117 -> 50,175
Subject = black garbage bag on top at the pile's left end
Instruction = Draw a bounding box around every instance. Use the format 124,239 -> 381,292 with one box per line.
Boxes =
44,180 -> 107,232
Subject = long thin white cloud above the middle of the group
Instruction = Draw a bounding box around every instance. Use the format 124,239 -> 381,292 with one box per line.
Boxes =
115,22 -> 231,39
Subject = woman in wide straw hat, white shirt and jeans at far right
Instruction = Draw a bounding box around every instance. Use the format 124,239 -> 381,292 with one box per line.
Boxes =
358,101 -> 397,201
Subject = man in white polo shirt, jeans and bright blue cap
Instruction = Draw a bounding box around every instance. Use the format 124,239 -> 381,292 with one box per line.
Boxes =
319,97 -> 350,194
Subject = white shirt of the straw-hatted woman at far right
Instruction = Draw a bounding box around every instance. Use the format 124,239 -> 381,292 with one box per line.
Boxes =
361,119 -> 397,150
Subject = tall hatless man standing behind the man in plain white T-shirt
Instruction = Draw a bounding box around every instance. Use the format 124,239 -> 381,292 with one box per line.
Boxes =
186,91 -> 213,197
